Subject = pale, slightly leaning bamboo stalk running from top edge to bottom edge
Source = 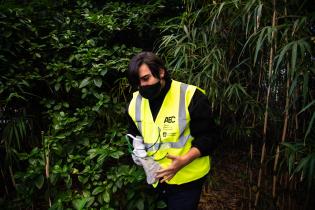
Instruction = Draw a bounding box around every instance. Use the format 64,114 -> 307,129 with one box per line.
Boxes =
255,0 -> 276,208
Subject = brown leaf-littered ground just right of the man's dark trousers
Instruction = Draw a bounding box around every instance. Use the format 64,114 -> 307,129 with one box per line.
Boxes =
198,145 -> 248,210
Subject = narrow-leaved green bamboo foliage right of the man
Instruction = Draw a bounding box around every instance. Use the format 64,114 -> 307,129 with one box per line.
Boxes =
158,0 -> 315,208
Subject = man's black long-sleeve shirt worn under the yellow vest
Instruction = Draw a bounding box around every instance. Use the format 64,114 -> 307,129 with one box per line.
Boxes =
127,80 -> 219,156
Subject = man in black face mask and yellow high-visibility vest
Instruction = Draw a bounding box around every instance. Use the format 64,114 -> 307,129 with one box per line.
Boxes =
128,52 -> 217,210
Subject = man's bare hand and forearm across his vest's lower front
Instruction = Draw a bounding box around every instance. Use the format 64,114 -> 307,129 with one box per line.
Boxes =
156,147 -> 201,183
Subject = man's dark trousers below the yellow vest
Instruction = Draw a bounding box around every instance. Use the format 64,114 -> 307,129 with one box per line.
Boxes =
158,177 -> 205,210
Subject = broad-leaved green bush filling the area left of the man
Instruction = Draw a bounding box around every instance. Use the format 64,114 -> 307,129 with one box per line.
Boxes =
0,1 -> 172,209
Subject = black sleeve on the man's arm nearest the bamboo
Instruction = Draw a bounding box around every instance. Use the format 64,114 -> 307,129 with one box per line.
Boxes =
188,89 -> 220,156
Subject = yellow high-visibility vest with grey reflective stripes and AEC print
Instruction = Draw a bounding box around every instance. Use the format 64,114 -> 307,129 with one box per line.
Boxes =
128,80 -> 210,184
